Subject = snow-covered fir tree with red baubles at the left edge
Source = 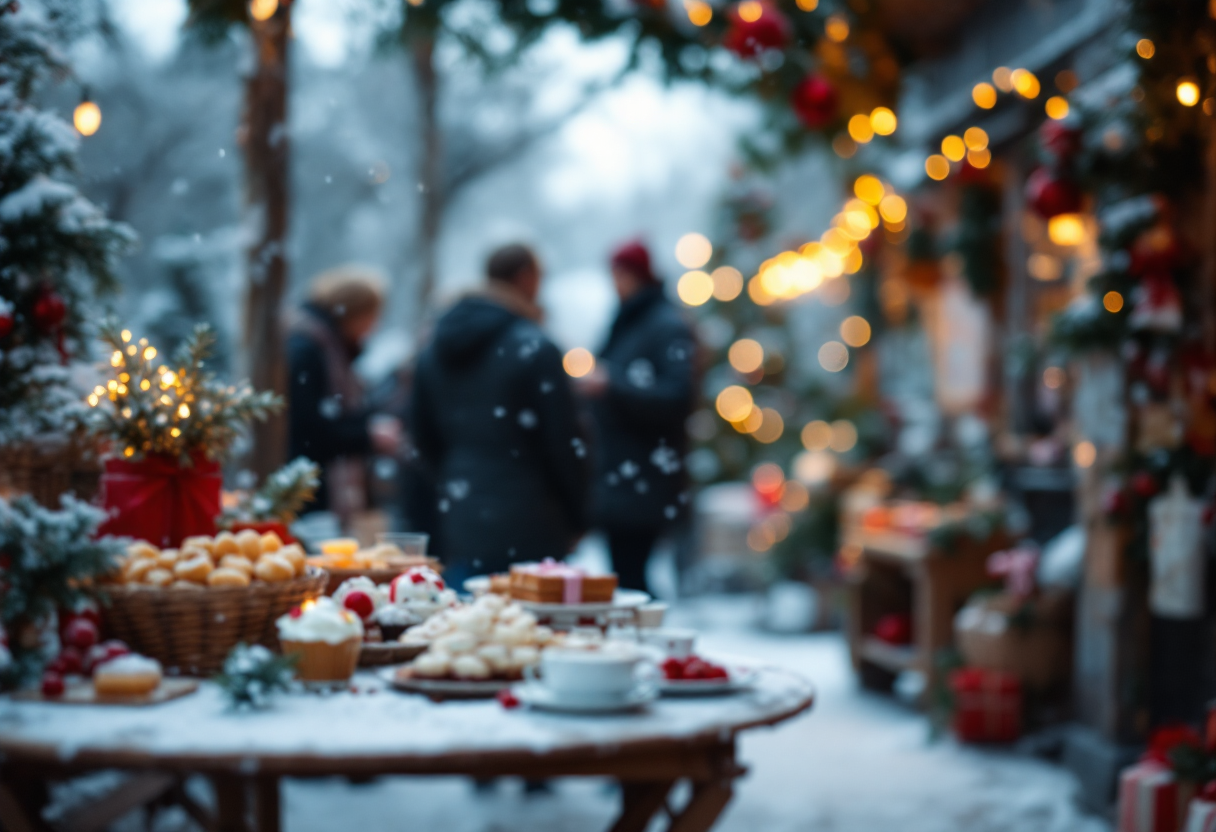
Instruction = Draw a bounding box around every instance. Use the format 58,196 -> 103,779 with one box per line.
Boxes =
0,0 -> 135,448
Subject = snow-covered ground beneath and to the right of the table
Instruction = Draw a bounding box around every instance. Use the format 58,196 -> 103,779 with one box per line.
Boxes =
271,600 -> 1109,832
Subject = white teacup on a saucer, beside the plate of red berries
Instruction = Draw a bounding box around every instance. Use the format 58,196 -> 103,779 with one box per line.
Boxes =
524,645 -> 653,702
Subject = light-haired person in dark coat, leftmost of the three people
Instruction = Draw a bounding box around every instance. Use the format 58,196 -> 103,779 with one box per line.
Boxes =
287,265 -> 401,522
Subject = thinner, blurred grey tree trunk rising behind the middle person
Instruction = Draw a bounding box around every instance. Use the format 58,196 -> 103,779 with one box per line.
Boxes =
409,36 -> 446,331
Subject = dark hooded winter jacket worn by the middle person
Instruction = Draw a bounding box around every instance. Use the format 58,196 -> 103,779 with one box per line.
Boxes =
412,289 -> 590,574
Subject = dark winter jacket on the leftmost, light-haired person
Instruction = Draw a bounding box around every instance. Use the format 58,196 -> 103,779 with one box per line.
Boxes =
287,304 -> 371,511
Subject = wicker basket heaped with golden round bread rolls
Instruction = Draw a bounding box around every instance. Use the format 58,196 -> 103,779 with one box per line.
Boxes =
105,529 -> 327,675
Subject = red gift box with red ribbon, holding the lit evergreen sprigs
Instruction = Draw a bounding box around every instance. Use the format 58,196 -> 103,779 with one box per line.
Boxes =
98,455 -> 224,546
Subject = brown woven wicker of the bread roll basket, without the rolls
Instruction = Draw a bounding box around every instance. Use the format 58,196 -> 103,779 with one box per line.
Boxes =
106,567 -> 328,675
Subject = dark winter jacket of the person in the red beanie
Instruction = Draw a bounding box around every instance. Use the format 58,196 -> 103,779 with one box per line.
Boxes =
592,286 -> 697,530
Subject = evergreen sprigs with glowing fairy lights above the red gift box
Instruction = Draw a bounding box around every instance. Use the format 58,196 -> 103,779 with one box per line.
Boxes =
88,327 -> 282,462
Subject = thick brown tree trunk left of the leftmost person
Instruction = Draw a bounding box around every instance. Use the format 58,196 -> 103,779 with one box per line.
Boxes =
241,2 -> 291,477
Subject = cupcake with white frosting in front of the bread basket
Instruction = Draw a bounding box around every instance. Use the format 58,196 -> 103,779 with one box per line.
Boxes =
275,598 -> 364,684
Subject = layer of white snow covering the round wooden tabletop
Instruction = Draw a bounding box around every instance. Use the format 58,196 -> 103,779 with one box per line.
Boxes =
0,668 -> 814,766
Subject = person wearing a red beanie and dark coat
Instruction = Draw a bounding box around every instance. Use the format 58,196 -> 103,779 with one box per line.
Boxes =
578,242 -> 697,590
